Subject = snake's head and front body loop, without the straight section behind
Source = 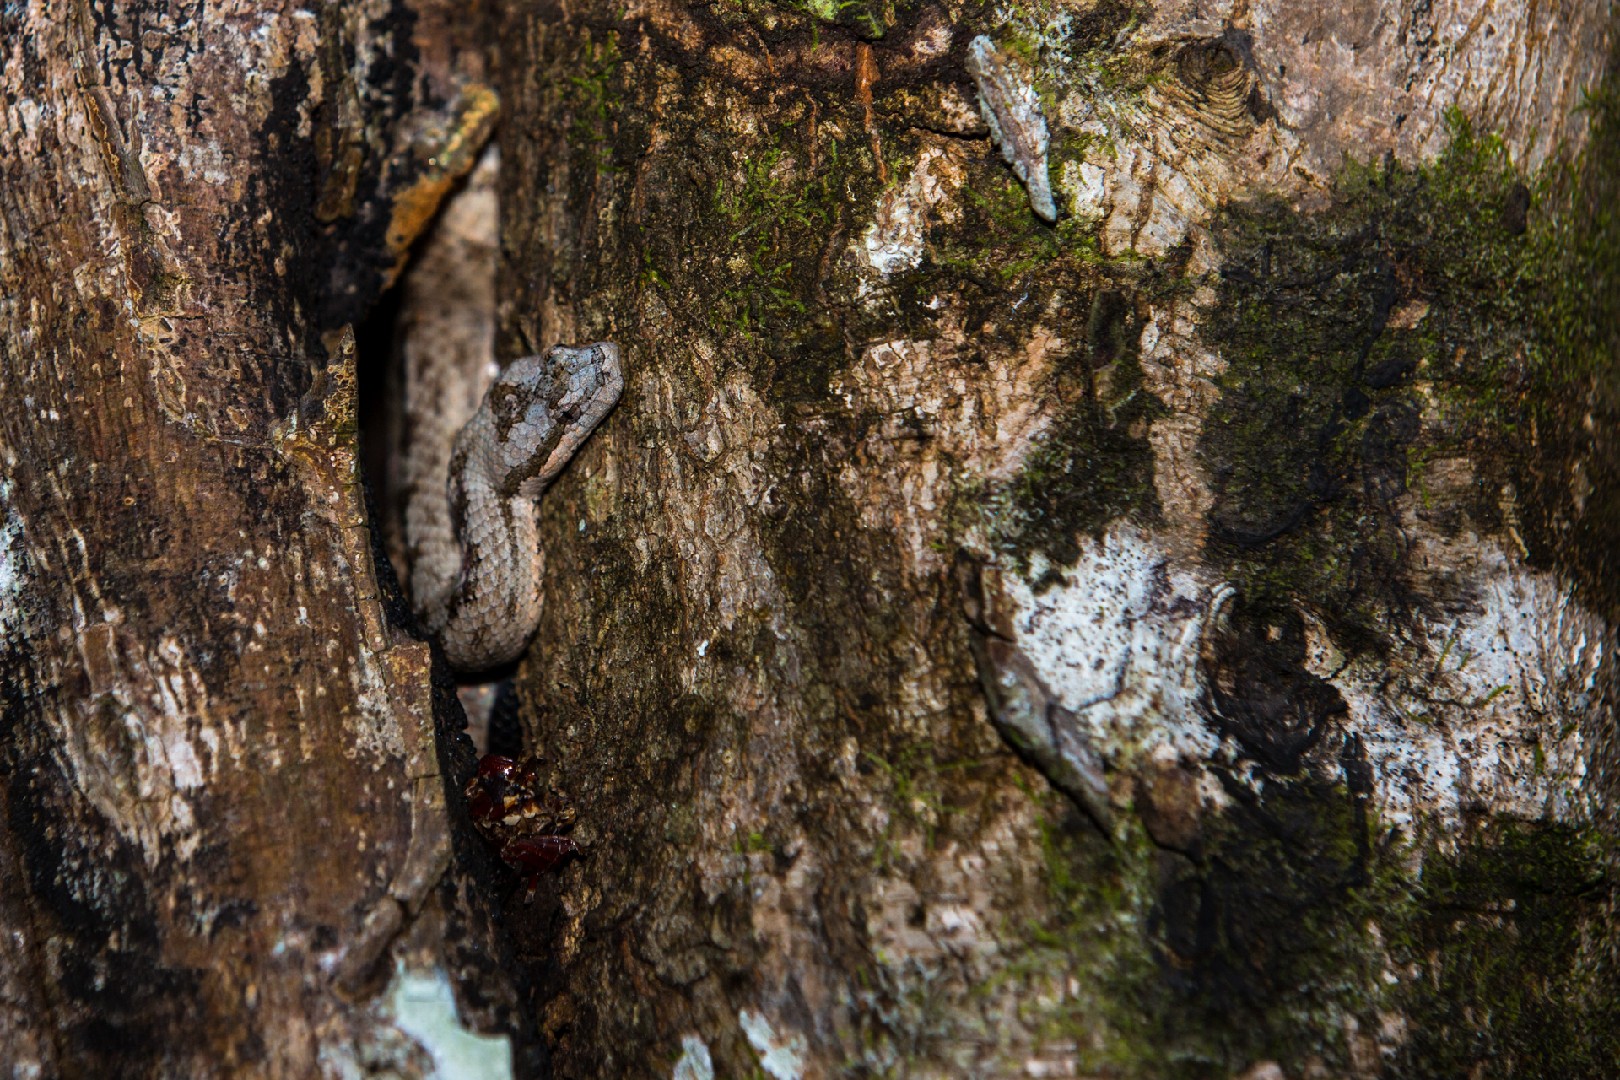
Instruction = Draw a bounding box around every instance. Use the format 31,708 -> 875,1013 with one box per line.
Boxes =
410,342 -> 624,672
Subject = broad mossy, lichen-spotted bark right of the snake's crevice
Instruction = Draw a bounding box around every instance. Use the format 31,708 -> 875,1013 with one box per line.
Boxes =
501,0 -> 1620,1078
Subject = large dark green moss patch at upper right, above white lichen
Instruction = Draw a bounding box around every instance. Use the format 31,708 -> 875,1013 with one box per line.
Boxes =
1202,99 -> 1617,646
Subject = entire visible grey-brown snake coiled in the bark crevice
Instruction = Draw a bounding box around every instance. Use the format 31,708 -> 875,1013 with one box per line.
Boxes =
397,154 -> 624,672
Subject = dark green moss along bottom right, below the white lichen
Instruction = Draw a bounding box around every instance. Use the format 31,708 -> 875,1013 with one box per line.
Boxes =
1023,771 -> 1620,1080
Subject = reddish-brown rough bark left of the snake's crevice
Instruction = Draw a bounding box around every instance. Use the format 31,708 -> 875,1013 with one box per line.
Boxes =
0,0 -> 533,1077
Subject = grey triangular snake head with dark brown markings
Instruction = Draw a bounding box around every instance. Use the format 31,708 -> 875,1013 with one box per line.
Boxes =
484,342 -> 624,499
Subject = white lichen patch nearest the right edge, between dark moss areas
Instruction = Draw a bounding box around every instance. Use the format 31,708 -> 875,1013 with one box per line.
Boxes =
1314,541 -> 1614,824
